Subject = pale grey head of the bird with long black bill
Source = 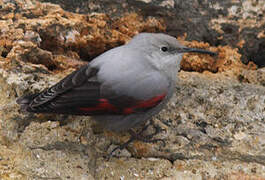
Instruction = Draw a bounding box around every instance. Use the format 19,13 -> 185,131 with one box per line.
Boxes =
128,33 -> 216,73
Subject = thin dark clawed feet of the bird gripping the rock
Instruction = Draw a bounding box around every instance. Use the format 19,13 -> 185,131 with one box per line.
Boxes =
107,121 -> 166,158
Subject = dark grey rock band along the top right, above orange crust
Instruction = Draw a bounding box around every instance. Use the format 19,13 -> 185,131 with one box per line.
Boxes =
39,0 -> 265,67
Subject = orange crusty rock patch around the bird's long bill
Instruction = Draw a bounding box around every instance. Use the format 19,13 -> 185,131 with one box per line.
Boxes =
181,41 -> 257,73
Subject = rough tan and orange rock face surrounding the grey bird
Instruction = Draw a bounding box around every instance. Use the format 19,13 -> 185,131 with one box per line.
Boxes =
0,0 -> 265,179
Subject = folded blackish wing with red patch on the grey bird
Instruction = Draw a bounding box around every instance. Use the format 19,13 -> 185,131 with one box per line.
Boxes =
17,65 -> 166,115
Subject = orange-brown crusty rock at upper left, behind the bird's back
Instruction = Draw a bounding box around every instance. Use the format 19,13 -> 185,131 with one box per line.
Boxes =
0,1 -> 165,71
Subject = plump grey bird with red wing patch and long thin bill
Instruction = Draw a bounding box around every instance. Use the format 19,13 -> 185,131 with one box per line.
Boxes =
17,33 -> 215,132
